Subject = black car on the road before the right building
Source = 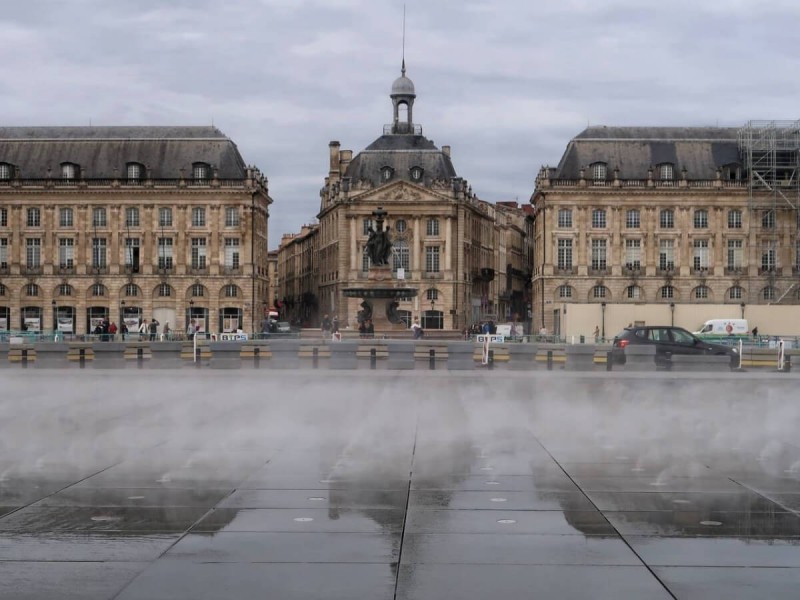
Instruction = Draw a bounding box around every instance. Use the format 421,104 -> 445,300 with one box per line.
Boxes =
611,325 -> 739,369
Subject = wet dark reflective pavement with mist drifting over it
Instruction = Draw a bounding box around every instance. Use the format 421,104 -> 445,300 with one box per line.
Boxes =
0,369 -> 800,600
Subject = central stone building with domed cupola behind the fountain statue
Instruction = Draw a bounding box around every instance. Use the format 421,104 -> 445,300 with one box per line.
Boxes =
316,64 -> 500,330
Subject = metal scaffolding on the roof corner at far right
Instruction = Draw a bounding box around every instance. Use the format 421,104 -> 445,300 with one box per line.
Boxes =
738,121 -> 800,211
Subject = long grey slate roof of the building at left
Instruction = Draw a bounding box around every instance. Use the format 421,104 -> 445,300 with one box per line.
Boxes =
0,126 -> 246,179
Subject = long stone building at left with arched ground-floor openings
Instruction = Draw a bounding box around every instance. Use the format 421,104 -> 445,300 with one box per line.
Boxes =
0,127 -> 272,333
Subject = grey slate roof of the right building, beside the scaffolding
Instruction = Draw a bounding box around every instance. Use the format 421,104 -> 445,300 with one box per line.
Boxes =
555,126 -> 742,179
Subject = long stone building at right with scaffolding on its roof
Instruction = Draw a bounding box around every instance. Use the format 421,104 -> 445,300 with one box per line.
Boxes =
531,122 -> 800,337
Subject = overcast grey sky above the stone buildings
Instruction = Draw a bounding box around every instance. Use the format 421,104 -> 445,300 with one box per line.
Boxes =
0,0 -> 800,249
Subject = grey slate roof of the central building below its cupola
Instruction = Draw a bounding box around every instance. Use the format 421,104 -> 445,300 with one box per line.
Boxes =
345,134 -> 456,187
